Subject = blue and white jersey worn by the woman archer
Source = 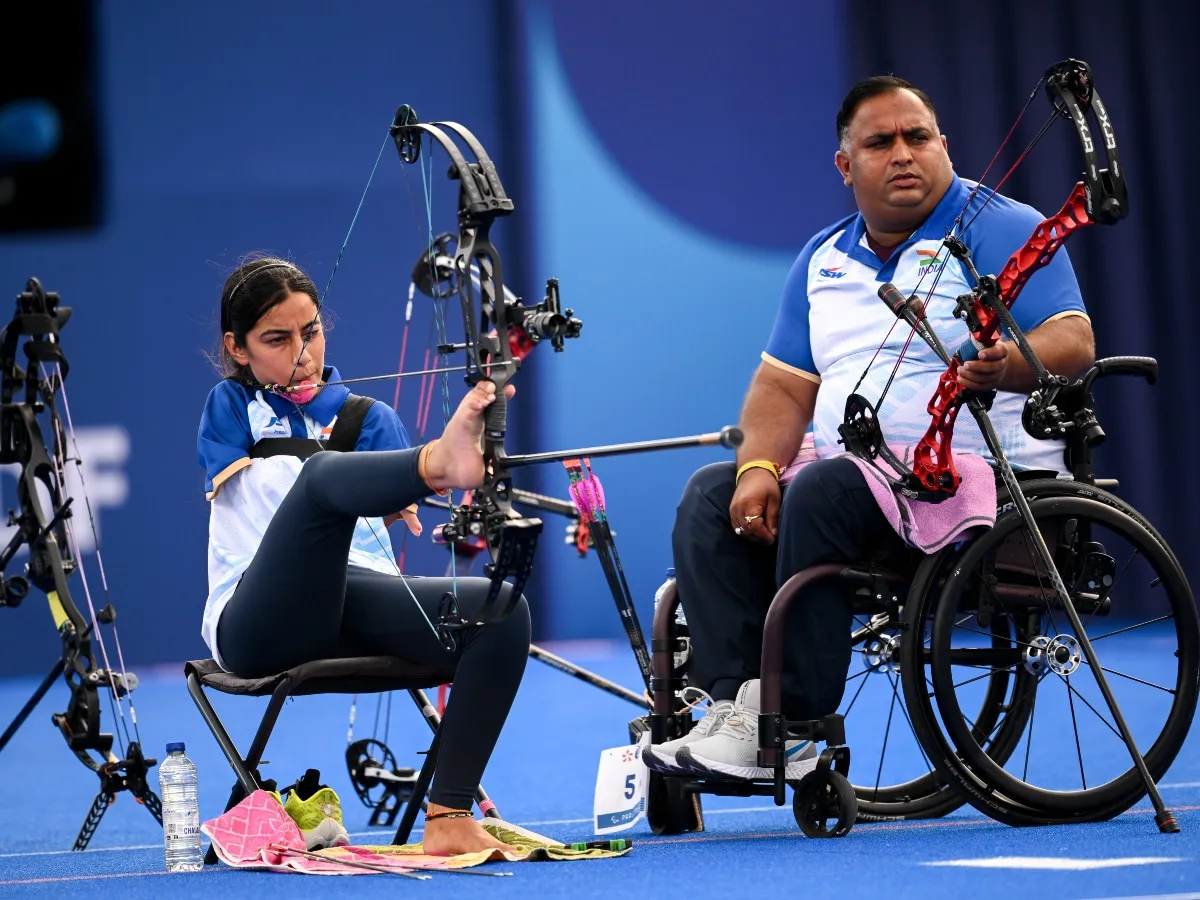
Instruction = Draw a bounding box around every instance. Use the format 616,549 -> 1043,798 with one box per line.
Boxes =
197,366 -> 410,665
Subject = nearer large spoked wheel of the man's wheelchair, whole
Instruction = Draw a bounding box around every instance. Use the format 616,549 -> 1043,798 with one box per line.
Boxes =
905,481 -> 1200,824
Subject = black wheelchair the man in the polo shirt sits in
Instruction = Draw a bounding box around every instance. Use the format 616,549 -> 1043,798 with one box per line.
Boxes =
648,356 -> 1200,838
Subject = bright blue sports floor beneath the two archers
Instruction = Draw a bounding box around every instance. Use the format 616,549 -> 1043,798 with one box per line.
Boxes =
0,641 -> 1200,900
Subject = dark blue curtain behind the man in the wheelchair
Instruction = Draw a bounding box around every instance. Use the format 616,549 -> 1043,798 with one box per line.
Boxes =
849,0 -> 1200,592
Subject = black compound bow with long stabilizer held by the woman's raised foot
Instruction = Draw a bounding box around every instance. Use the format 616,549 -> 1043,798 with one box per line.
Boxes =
259,104 -> 742,647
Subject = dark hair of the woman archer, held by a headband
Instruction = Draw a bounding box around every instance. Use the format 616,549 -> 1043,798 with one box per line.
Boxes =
217,256 -> 320,380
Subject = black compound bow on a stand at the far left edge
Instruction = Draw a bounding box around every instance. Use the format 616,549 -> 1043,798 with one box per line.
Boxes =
0,278 -> 162,850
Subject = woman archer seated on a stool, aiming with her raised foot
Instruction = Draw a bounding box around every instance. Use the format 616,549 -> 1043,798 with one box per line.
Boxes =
197,258 -> 529,854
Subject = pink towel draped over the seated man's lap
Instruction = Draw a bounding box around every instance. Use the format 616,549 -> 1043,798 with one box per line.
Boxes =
780,433 -> 996,553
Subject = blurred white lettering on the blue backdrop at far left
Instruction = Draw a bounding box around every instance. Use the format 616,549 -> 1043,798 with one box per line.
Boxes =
0,425 -> 130,553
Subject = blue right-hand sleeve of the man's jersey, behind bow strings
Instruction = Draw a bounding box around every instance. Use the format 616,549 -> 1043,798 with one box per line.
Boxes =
971,198 -> 1087,334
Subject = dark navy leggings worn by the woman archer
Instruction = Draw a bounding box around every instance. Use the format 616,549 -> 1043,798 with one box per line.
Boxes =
217,449 -> 529,809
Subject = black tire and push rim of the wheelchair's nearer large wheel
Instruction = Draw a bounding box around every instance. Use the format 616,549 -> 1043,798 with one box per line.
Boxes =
901,479 -> 1200,826
